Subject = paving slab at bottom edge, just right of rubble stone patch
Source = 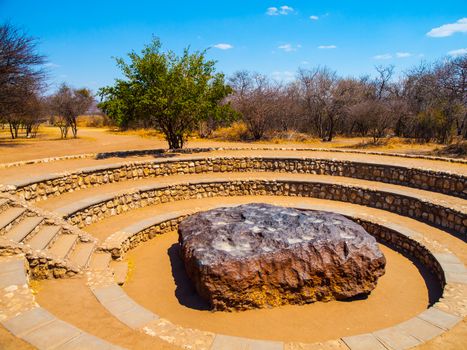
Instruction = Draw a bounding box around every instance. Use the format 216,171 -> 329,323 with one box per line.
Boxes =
211,334 -> 284,350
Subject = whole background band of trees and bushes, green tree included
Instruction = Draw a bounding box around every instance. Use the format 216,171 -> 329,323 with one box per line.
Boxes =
0,24 -> 467,150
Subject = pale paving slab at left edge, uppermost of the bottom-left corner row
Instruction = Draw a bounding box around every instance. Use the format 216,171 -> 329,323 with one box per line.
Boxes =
2,307 -> 55,336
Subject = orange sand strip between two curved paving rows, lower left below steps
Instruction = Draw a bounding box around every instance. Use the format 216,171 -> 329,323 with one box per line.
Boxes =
35,278 -> 177,350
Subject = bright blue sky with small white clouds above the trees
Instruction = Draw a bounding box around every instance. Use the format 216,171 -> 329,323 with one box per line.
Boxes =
0,0 -> 467,91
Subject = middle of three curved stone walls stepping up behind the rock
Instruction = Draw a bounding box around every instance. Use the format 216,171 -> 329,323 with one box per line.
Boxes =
66,180 -> 467,238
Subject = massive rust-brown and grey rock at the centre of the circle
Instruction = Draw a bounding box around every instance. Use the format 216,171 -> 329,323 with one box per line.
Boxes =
178,204 -> 386,310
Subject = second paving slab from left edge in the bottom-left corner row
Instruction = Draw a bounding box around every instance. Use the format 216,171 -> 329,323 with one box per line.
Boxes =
21,319 -> 81,349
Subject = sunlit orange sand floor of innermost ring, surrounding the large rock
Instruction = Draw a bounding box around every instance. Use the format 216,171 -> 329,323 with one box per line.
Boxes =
124,232 -> 436,342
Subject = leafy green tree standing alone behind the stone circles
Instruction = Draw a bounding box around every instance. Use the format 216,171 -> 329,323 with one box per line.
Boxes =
99,38 -> 234,149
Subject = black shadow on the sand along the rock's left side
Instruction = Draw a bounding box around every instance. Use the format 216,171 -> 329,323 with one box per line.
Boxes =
167,243 -> 211,311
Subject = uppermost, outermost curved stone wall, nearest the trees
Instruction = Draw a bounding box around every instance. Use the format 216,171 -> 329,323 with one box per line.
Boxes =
11,157 -> 467,201
